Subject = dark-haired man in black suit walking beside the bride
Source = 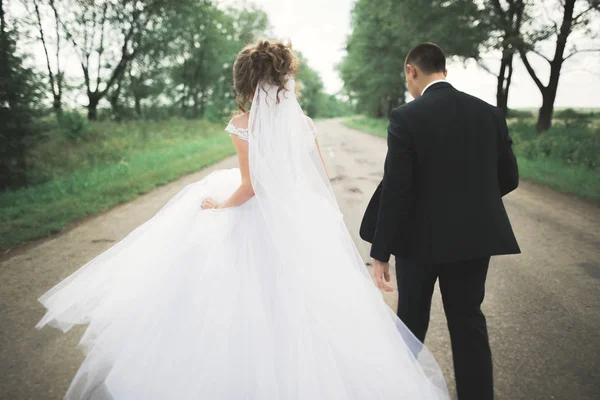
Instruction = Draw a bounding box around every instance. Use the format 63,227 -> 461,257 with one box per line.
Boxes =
361,43 -> 520,400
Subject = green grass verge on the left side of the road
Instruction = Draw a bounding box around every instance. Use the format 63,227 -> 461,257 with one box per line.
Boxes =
0,120 -> 235,250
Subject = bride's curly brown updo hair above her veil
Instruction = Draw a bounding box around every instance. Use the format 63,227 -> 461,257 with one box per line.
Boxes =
233,40 -> 298,112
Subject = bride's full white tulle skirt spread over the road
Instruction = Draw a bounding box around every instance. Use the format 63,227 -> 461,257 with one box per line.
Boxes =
37,169 -> 448,400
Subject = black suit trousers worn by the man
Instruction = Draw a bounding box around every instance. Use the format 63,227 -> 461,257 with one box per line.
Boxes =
396,257 -> 494,400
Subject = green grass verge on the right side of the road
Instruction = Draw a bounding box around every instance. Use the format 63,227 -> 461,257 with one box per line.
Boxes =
344,116 -> 600,204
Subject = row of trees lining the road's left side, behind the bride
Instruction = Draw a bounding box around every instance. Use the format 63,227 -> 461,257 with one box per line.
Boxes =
0,0 -> 350,189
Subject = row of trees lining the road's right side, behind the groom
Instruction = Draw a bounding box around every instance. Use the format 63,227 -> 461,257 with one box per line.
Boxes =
339,0 -> 600,133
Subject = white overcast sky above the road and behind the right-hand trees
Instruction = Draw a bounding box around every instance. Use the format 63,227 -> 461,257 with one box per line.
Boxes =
222,0 -> 600,108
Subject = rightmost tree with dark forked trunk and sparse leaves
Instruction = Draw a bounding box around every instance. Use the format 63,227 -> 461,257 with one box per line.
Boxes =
517,0 -> 600,133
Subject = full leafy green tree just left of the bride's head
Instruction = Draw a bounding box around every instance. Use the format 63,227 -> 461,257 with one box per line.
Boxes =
79,0 -> 268,119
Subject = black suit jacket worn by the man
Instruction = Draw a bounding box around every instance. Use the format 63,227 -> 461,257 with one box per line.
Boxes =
360,82 -> 520,264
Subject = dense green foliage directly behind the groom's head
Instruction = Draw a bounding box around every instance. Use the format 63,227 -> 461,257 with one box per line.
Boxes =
338,0 -> 486,118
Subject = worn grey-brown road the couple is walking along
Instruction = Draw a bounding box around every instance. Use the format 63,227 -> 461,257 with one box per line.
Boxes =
0,120 -> 600,400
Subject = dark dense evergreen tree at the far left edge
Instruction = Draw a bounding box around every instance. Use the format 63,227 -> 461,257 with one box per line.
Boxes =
0,0 -> 39,189
